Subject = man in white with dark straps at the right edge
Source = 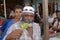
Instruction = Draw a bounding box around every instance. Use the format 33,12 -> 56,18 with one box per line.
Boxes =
50,10 -> 60,32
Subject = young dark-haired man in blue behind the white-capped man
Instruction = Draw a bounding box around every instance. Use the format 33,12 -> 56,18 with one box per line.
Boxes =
1,5 -> 22,40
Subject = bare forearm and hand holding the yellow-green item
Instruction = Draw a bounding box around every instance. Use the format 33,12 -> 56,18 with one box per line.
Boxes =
6,30 -> 22,40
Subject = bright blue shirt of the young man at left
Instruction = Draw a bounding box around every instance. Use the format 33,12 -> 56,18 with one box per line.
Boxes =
0,19 -> 14,40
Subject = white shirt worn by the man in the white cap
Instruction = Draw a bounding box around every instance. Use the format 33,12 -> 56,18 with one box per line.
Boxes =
3,22 -> 41,40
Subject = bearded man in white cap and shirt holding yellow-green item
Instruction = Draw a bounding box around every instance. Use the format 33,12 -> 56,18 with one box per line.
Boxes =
5,6 -> 41,40
